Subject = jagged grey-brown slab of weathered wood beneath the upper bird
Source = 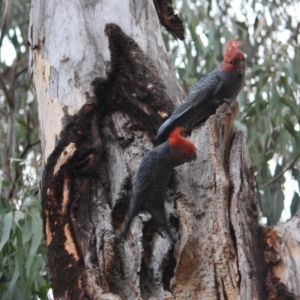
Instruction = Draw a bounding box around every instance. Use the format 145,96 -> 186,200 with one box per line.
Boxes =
172,102 -> 266,299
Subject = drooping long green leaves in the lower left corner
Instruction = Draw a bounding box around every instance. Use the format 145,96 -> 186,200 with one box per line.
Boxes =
0,197 -> 50,299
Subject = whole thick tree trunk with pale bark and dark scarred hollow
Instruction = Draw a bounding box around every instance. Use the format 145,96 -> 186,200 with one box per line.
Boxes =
29,0 -> 300,300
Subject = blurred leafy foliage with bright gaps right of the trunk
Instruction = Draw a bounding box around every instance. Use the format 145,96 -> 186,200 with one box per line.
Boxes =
164,0 -> 300,224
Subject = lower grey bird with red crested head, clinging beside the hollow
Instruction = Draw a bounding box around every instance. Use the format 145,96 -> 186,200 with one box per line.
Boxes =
123,127 -> 197,242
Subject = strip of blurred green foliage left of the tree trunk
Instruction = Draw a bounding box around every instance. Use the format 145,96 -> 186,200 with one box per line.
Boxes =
0,0 -> 49,300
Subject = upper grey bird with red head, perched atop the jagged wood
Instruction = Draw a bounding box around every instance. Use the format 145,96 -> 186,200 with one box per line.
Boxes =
156,41 -> 246,143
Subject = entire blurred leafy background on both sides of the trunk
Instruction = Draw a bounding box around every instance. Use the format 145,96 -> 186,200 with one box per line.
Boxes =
0,0 -> 300,299
